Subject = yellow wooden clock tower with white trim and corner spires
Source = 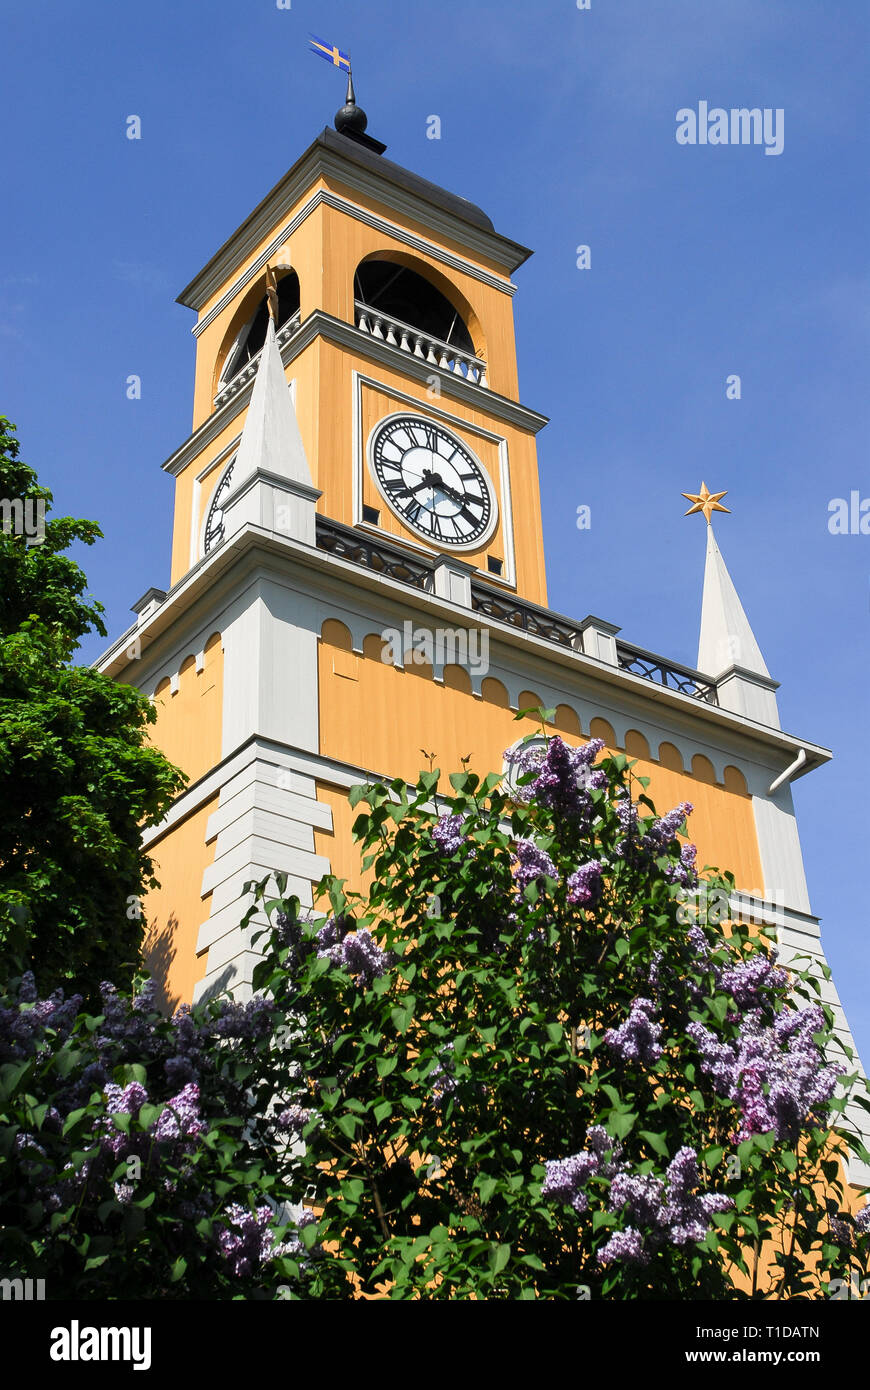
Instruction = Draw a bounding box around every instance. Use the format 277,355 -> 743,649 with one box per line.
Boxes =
91,81 -> 870,1180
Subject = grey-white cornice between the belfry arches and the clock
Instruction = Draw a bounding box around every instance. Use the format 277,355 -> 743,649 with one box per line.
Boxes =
161,309 -> 549,477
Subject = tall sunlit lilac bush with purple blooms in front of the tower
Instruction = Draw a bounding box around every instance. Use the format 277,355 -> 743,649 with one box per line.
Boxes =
237,737 -> 870,1298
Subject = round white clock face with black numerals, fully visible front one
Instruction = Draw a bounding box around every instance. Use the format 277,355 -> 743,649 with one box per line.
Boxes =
368,414 -> 496,548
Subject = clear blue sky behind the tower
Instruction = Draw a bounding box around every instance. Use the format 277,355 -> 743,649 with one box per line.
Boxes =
0,0 -> 870,1065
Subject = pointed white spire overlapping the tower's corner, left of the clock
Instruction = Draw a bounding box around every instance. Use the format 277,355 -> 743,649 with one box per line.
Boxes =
233,314 -> 311,487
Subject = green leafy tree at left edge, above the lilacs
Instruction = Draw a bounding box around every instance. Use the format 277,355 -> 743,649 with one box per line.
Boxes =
0,417 -> 185,998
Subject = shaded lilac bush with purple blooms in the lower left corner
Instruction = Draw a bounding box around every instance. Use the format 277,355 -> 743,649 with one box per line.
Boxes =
0,973 -> 323,1298
